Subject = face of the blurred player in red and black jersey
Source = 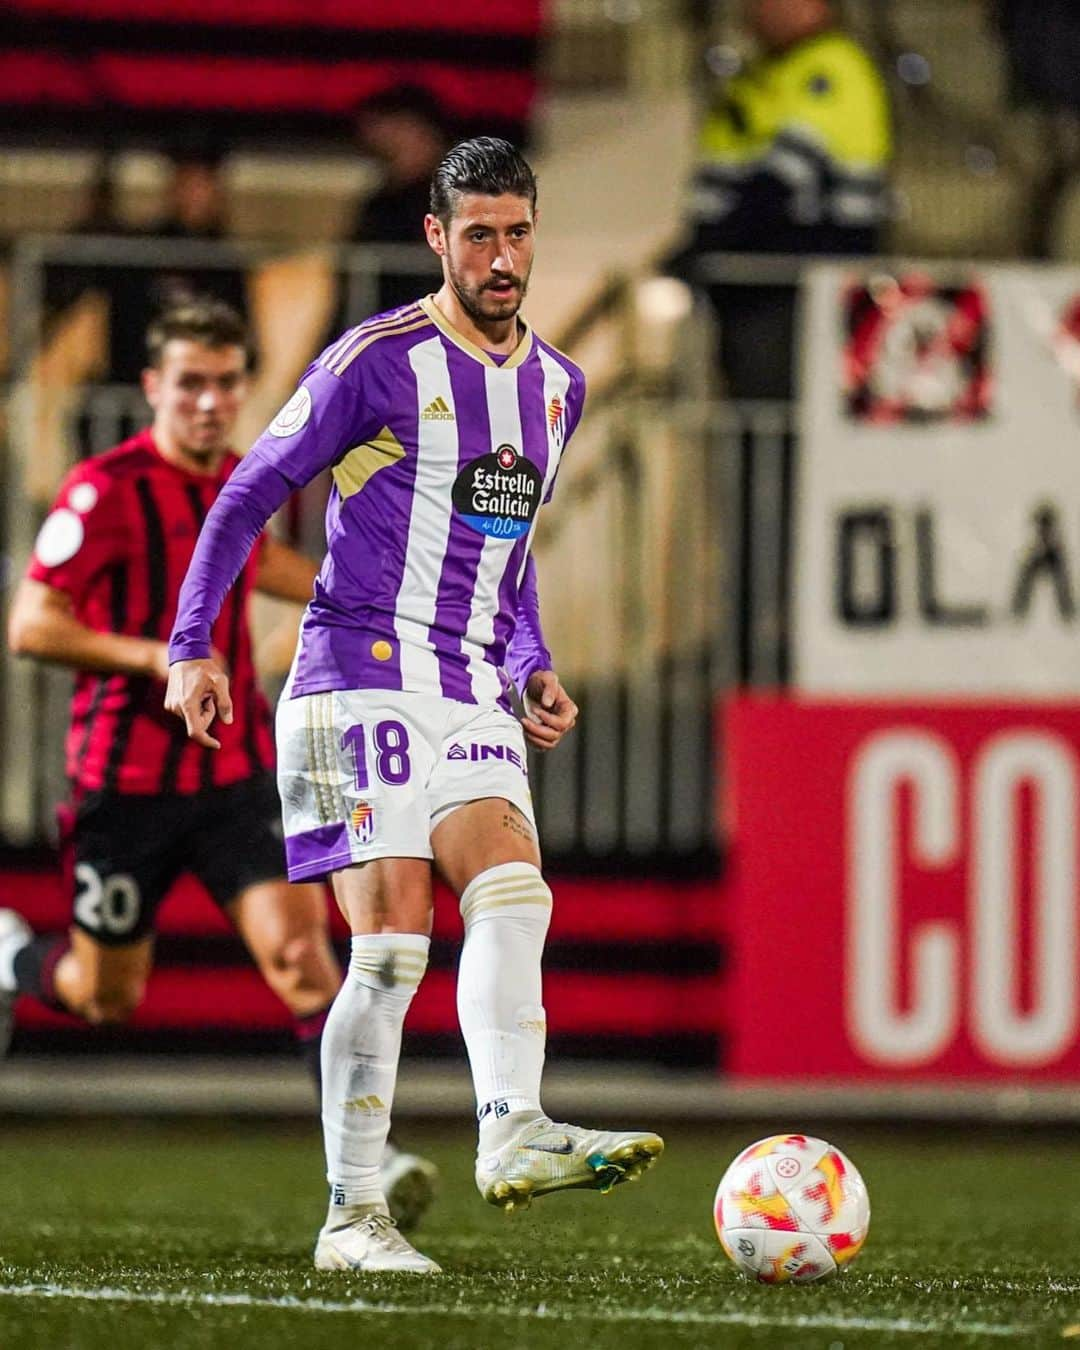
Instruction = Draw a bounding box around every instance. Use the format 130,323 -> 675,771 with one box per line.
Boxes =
146,339 -> 247,463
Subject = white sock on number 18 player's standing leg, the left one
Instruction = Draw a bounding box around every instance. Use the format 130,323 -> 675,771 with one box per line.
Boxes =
323,933 -> 429,1222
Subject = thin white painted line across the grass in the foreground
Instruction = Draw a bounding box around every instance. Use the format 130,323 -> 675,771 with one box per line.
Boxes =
0,1284 -> 1037,1337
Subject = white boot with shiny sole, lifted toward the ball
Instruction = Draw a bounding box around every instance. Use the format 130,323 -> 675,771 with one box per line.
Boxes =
477,1118 -> 664,1211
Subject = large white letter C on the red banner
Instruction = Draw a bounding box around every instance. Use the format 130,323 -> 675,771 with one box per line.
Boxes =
844,729 -> 960,1067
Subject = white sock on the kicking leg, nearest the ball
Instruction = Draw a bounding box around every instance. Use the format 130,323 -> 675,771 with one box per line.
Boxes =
458,863 -> 551,1150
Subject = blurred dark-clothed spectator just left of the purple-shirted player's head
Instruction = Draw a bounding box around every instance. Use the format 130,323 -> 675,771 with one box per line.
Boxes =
346,85 -> 452,315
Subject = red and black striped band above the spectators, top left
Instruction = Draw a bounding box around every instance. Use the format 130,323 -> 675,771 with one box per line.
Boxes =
0,0 -> 545,146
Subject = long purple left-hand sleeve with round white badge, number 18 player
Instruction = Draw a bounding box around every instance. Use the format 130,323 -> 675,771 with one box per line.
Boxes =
169,365 -> 381,663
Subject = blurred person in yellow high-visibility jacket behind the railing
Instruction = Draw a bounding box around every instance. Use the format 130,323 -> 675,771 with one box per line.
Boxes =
678,0 -> 891,398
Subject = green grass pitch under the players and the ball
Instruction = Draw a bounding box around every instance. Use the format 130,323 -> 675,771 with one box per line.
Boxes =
0,1119 -> 1080,1350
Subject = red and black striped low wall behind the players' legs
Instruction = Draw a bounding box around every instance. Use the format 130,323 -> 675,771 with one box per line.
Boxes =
8,869 -> 722,1056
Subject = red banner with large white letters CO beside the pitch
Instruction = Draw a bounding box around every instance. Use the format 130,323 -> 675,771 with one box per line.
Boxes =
726,697 -> 1080,1081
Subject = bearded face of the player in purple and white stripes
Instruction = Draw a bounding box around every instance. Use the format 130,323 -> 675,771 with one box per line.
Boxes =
444,193 -> 535,324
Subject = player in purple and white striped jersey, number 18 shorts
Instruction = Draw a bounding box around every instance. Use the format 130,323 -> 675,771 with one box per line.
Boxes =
166,136 -> 663,1273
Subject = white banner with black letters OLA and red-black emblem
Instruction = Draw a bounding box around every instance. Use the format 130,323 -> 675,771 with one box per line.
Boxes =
794,263 -> 1080,699
